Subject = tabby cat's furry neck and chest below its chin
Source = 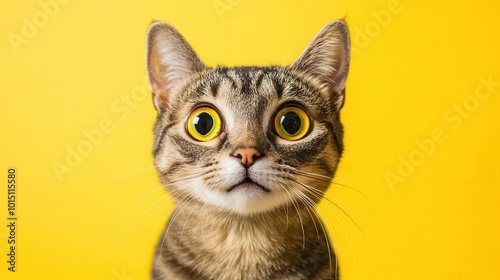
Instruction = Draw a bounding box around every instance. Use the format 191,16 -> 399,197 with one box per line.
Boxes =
158,201 -> 336,279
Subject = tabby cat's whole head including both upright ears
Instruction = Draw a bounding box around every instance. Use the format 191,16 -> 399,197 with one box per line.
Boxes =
147,20 -> 350,214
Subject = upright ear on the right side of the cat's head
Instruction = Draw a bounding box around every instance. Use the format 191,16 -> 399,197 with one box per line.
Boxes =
290,20 -> 351,110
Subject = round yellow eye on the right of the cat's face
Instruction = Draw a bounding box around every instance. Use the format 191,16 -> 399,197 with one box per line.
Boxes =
274,106 -> 310,141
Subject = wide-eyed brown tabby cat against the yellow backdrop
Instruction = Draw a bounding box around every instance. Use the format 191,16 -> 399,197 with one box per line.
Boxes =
147,20 -> 350,280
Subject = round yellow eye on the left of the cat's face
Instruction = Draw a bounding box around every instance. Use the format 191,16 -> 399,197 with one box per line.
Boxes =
187,107 -> 222,142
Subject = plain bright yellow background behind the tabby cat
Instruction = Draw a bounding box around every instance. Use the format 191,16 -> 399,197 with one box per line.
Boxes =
0,0 -> 500,280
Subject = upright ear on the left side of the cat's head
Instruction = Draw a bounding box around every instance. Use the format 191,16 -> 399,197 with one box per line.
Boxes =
146,21 -> 206,111
